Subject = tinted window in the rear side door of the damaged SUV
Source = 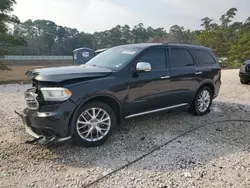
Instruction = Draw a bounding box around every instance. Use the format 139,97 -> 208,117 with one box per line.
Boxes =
170,48 -> 194,68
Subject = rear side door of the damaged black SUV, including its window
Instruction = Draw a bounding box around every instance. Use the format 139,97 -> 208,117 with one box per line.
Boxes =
170,47 -> 199,105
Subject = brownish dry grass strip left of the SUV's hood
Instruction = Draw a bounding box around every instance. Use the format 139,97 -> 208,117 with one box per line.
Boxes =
0,65 -> 41,84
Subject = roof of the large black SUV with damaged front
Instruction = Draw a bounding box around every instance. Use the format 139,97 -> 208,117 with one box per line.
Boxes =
115,43 -> 211,51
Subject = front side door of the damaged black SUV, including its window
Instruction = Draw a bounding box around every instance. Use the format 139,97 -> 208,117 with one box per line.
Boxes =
127,48 -> 170,115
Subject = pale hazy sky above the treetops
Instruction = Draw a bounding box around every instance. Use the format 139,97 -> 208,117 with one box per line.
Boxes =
14,0 -> 250,33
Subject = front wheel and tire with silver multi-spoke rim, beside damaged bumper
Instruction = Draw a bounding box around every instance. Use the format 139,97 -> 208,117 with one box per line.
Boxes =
73,102 -> 117,147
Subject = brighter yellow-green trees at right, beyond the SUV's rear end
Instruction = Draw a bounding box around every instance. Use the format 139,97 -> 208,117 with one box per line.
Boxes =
195,8 -> 250,68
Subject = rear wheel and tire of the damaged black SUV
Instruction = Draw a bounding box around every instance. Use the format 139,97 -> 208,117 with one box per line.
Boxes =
189,86 -> 213,116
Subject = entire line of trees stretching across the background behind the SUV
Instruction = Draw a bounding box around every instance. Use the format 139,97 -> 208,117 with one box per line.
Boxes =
0,5 -> 250,67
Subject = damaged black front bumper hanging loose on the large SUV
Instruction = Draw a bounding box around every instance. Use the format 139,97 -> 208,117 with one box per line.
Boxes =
16,101 -> 76,141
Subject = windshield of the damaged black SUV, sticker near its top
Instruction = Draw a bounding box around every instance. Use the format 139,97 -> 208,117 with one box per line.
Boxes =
86,46 -> 142,70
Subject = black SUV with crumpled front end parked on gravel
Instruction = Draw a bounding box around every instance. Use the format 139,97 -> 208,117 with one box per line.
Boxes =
16,43 -> 221,146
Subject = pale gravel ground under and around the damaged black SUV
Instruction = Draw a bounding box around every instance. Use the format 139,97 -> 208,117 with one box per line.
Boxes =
0,70 -> 250,188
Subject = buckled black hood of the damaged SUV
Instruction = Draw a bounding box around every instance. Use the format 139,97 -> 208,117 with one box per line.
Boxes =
25,65 -> 112,82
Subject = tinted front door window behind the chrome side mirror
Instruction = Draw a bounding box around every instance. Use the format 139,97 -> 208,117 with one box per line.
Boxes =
137,49 -> 166,70
